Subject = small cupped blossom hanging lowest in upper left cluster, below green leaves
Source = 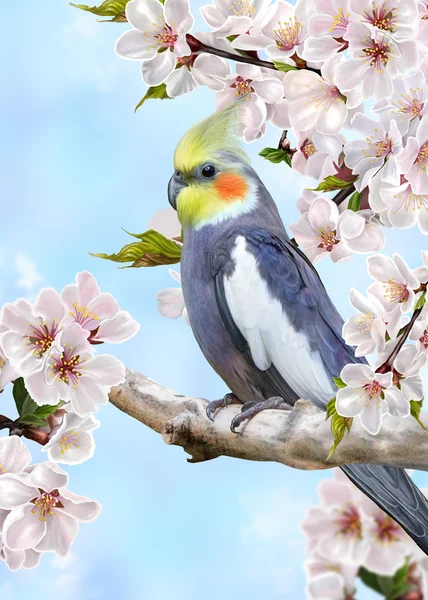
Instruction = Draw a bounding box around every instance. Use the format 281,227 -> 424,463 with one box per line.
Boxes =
42,412 -> 100,465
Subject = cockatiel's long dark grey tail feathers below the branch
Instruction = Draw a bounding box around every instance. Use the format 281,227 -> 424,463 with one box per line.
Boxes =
341,464 -> 428,554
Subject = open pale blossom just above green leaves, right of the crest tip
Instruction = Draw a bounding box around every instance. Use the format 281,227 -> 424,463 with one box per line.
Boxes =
344,113 -> 402,190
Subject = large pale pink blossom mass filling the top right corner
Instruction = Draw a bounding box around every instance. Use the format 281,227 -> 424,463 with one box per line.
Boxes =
116,0 -> 428,262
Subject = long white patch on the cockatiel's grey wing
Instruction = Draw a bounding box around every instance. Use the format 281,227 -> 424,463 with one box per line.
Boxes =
224,236 -> 334,401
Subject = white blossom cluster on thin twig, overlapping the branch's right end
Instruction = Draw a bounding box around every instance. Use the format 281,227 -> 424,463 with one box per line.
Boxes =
336,252 -> 428,435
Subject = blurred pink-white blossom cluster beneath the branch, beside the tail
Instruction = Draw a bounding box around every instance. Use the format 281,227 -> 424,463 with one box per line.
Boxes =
302,469 -> 428,600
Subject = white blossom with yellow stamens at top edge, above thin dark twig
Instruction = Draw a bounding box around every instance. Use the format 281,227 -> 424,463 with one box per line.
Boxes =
232,0 -> 312,62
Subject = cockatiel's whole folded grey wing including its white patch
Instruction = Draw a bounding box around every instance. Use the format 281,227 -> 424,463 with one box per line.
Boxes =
211,227 -> 358,406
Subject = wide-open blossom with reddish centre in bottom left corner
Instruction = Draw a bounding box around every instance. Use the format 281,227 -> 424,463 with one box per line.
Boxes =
0,462 -> 101,556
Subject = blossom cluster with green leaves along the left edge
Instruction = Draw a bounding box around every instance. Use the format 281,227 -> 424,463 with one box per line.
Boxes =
0,271 -> 139,569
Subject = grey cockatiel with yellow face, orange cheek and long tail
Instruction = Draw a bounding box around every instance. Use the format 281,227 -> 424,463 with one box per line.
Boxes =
168,101 -> 428,553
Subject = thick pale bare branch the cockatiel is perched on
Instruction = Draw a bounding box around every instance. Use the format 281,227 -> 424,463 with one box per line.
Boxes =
110,370 -> 428,471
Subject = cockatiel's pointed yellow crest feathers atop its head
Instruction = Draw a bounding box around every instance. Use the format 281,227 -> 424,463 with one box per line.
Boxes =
174,97 -> 250,174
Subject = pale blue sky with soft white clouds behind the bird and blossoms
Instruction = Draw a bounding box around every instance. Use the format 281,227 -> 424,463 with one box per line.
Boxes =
0,0 -> 428,600
